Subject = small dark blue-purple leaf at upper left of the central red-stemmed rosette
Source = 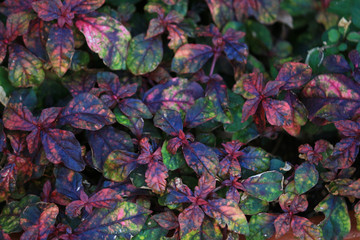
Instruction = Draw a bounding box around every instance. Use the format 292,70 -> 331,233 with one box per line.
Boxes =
154,109 -> 183,136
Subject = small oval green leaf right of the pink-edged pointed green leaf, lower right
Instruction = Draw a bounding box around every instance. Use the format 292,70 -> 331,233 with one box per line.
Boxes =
294,162 -> 319,194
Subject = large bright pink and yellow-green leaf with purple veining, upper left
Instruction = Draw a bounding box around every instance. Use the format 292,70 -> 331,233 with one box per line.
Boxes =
75,15 -> 131,70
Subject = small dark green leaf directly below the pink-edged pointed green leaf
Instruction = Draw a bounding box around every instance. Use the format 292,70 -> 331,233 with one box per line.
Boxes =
239,193 -> 269,215
